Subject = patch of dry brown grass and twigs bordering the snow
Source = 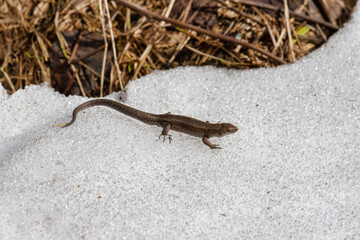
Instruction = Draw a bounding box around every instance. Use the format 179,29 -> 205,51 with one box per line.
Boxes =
0,0 -> 355,96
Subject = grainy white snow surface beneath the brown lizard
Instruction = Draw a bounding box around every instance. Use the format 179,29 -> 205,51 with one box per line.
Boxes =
0,6 -> 360,239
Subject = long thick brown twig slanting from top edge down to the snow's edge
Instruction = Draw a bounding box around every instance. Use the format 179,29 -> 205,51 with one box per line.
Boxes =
115,0 -> 286,64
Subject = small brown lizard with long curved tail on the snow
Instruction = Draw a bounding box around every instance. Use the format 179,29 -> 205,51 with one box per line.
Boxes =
62,99 -> 238,149
